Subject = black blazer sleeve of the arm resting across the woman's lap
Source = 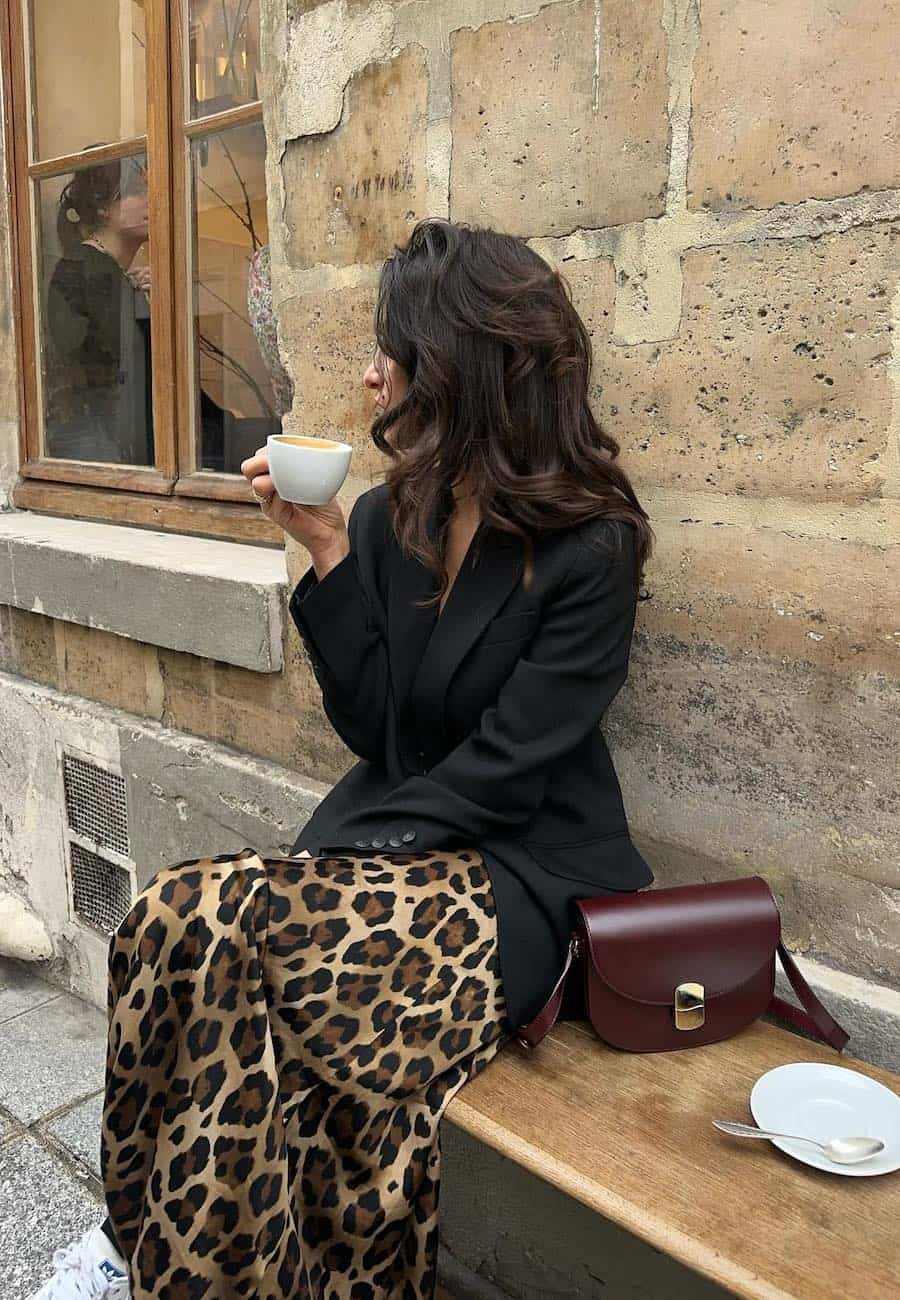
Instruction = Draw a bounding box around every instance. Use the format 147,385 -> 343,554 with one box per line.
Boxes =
320,524 -> 637,852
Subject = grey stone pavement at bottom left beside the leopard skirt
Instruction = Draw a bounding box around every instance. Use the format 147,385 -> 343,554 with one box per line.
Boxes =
0,958 -> 107,1300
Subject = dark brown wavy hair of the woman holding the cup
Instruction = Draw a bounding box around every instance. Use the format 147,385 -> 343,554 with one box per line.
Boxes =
372,218 -> 653,605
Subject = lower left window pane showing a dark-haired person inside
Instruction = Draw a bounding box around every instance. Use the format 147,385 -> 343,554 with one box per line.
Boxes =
35,155 -> 153,465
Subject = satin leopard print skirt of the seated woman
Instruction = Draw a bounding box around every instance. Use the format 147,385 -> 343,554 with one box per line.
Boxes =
101,848 -> 510,1300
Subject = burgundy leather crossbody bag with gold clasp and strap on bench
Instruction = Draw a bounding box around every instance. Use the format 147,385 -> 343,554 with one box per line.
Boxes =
518,876 -> 848,1052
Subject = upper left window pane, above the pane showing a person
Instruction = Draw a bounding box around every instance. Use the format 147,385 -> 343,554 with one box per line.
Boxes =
29,0 -> 147,159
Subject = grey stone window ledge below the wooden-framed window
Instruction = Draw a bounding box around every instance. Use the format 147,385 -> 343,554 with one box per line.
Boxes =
0,511 -> 287,672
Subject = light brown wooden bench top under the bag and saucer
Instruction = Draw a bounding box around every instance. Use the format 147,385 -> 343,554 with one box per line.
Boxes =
446,1022 -> 900,1300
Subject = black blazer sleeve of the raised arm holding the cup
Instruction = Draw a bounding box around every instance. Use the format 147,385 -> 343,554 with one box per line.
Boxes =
289,497 -> 389,762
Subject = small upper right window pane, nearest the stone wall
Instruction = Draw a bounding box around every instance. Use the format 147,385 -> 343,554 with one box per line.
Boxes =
187,0 -> 263,117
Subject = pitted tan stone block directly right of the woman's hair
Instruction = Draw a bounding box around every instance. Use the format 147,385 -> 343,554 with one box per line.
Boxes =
577,222 -> 900,501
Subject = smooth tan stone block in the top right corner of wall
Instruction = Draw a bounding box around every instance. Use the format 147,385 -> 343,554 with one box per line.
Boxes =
688,0 -> 900,209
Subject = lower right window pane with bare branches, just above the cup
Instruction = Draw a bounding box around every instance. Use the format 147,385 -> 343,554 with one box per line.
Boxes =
191,122 -> 291,473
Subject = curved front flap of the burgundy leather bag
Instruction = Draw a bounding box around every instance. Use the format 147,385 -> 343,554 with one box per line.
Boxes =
576,876 -> 782,1006
